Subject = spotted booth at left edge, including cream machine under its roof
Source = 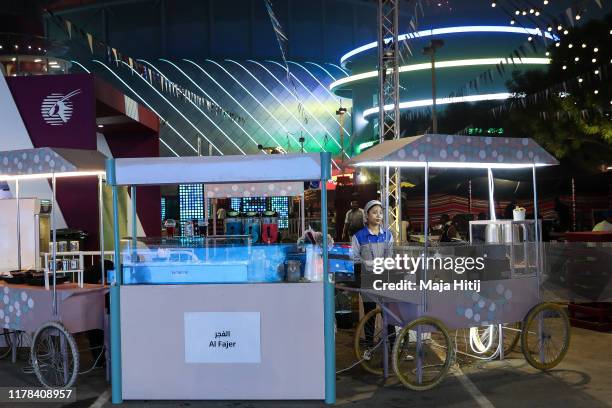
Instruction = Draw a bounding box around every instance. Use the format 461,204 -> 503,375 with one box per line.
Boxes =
0,147 -> 106,388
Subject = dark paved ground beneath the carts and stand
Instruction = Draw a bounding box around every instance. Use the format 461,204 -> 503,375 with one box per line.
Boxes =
0,329 -> 612,408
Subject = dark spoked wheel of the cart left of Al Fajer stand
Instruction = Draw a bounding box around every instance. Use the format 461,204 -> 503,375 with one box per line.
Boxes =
30,322 -> 79,388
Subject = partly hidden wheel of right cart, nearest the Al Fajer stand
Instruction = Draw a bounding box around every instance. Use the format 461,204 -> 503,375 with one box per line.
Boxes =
354,308 -> 383,375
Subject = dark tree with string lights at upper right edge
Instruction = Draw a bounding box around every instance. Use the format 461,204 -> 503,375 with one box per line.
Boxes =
505,15 -> 612,171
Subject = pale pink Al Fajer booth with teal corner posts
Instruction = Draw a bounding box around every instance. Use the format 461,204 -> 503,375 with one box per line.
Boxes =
107,153 -> 335,403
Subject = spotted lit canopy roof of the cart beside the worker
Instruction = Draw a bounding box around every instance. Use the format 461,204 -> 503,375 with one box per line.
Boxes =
349,134 -> 559,168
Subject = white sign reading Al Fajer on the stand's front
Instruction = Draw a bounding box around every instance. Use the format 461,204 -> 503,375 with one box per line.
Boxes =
184,312 -> 261,363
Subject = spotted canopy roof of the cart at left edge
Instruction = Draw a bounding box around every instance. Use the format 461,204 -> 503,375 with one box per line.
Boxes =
0,147 -> 106,178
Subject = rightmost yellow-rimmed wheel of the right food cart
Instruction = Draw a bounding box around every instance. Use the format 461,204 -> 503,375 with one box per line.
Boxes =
521,303 -> 570,370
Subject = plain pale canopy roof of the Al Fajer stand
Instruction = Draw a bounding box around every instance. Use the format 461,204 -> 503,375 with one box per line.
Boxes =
111,153 -> 329,185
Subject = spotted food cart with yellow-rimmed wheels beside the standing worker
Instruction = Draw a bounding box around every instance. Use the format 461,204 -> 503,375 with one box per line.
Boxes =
342,134 -> 570,390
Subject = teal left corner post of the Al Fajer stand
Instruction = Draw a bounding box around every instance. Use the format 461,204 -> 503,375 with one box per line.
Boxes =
106,159 -> 123,404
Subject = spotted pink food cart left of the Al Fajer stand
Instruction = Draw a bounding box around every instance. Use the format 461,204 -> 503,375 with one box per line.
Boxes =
0,147 -> 106,388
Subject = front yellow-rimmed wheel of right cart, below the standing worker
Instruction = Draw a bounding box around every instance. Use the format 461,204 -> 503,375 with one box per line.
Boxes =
393,317 -> 455,391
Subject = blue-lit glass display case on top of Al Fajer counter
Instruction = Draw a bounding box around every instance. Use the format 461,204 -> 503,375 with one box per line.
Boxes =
121,235 -> 323,285
